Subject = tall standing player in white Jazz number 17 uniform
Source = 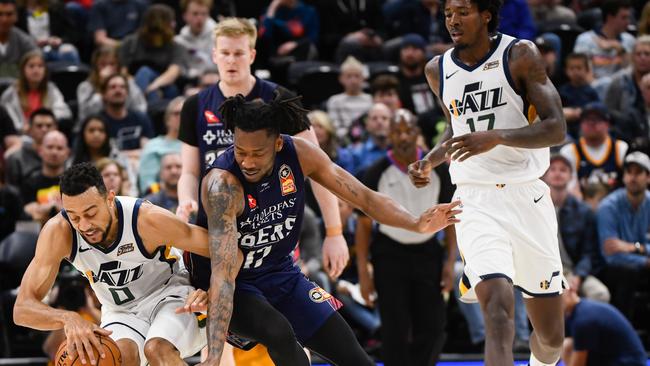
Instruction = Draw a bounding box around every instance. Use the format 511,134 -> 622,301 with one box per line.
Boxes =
409,0 -> 566,366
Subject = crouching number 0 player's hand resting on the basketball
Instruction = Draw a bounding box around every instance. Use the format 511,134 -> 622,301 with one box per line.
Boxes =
63,312 -> 113,365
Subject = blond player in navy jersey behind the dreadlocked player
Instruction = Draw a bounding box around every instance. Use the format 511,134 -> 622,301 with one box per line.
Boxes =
177,18 -> 349,289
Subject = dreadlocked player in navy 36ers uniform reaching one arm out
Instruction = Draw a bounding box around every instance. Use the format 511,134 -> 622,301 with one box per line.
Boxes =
201,96 -> 460,366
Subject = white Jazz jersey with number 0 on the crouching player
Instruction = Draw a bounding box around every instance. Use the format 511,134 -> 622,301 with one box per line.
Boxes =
61,196 -> 183,310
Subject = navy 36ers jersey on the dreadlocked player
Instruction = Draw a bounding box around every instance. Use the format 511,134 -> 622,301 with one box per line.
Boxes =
212,135 -> 305,279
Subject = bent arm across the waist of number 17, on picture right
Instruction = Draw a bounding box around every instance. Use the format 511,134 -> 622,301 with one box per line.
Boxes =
498,40 -> 566,148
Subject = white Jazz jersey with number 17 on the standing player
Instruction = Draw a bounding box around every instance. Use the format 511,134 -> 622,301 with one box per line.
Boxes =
439,33 -> 549,184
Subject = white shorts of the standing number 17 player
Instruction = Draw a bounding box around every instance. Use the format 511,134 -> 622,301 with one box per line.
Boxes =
454,180 -> 566,302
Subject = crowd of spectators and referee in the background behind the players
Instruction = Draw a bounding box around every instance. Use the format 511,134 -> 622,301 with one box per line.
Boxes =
0,0 -> 650,365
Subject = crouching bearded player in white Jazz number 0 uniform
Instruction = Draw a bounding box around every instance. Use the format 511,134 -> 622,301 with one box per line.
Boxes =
14,163 -> 218,365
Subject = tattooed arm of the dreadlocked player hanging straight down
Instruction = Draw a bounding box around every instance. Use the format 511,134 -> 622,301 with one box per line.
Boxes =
201,169 -> 244,364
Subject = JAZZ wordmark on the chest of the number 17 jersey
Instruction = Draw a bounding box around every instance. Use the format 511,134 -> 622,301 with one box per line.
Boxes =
448,81 -> 508,117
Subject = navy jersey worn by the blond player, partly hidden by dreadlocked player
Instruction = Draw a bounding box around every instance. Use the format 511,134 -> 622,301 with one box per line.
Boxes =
196,78 -> 278,228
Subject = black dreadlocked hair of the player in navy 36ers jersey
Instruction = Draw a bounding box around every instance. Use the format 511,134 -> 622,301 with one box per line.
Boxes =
219,91 -> 309,134
